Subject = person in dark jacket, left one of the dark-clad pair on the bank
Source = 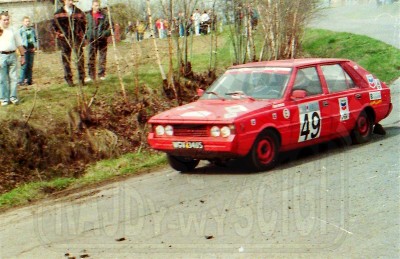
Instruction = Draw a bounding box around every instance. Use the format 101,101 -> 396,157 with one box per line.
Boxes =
53,0 -> 86,86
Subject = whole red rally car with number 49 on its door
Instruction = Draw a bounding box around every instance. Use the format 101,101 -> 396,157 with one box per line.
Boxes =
148,59 -> 392,171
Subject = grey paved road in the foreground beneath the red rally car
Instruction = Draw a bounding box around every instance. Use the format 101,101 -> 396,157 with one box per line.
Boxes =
0,2 -> 400,258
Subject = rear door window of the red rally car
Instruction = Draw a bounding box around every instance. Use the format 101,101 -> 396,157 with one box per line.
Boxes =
321,64 -> 355,93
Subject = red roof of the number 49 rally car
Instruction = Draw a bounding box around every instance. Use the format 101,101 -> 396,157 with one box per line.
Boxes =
230,58 -> 349,68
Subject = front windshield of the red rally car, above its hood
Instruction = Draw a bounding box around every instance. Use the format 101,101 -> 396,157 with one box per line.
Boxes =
201,67 -> 292,100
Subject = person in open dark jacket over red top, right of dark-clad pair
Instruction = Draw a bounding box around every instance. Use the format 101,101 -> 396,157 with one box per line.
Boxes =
85,0 -> 111,82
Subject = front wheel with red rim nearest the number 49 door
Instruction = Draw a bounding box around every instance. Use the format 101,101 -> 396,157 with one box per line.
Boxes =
247,129 -> 280,171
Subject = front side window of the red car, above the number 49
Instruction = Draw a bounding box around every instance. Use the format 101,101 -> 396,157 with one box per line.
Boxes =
293,67 -> 322,96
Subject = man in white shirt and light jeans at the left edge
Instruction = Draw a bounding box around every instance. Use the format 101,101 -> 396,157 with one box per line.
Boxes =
0,12 -> 25,106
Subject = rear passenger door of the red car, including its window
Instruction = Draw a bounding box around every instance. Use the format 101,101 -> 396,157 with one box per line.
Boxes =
321,64 -> 362,136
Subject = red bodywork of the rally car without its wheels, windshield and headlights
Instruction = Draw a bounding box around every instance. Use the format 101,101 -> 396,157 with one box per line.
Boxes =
148,59 -> 392,160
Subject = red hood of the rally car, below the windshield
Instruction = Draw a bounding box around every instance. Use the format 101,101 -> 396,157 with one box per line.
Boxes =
149,99 -> 276,123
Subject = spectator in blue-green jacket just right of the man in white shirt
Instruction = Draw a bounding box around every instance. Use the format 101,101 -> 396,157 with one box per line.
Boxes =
18,16 -> 37,85
